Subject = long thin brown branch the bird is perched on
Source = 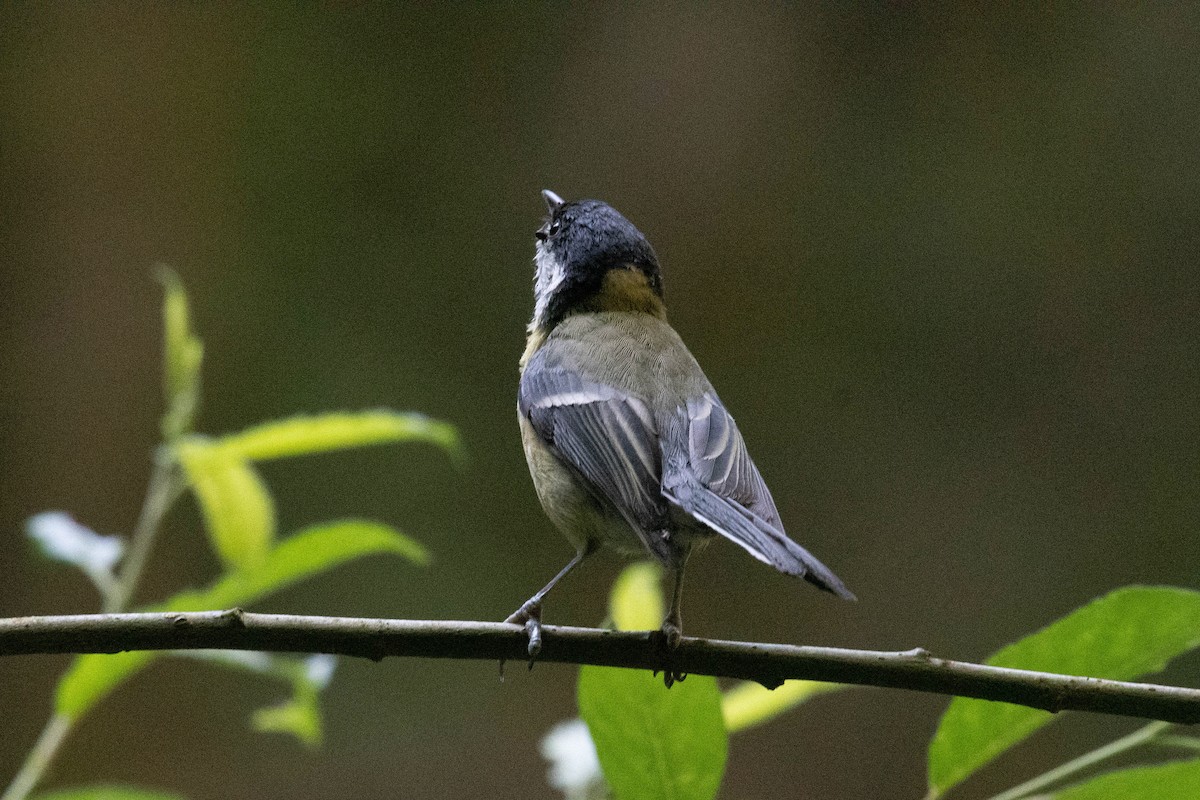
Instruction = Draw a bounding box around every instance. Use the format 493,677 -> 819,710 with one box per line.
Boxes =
0,608 -> 1200,723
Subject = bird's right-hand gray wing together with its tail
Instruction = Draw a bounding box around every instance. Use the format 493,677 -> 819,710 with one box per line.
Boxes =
662,392 -> 854,600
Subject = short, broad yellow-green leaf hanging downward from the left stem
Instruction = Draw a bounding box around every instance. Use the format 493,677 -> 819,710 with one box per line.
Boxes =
176,437 -> 275,570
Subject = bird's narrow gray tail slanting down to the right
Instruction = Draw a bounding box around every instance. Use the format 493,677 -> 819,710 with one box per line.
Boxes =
667,485 -> 857,600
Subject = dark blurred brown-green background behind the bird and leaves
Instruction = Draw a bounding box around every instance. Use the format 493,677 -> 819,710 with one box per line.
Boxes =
0,2 -> 1200,798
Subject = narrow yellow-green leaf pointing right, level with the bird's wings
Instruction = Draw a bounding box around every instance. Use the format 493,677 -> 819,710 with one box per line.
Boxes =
220,409 -> 458,461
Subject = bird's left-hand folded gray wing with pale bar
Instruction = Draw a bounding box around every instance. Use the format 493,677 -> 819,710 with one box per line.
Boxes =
517,361 -> 667,549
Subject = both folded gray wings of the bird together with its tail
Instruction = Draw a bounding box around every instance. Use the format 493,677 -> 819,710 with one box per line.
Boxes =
517,351 -> 853,599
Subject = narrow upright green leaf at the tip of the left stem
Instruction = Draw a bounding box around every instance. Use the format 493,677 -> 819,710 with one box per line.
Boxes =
158,265 -> 204,441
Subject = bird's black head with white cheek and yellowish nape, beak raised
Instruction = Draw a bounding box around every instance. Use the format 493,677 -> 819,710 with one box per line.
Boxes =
529,190 -> 665,332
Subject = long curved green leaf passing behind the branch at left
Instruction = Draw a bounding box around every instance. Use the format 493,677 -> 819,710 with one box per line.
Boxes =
55,521 -> 428,718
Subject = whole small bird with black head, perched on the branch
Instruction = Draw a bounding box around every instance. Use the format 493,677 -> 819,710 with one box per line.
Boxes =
505,190 -> 854,662
